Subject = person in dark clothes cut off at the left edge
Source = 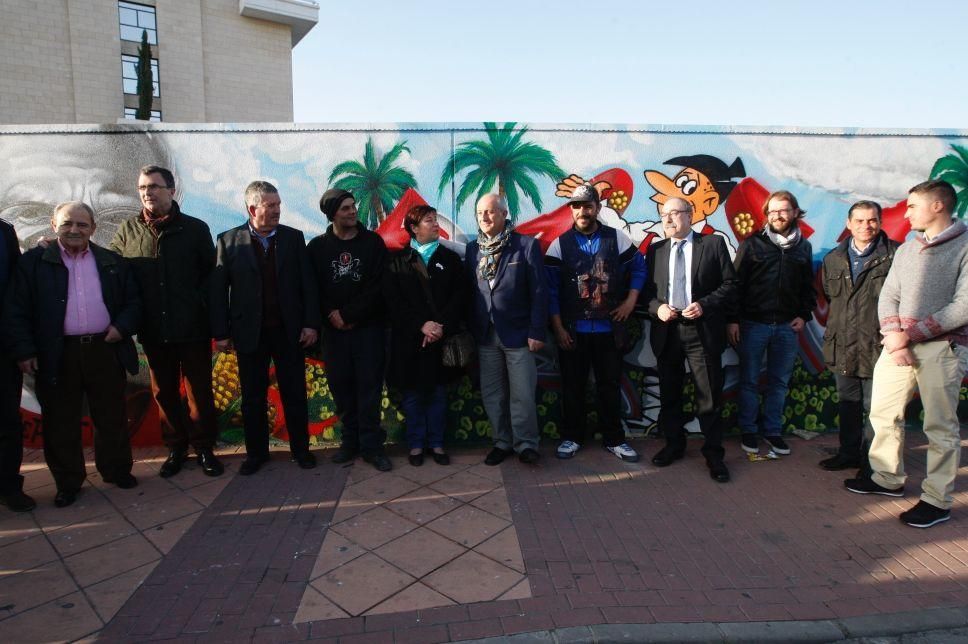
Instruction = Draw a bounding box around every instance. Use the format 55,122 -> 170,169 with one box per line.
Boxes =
0,219 -> 37,512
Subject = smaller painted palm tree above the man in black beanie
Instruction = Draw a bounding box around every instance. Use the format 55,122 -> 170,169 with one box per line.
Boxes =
329,137 -> 417,228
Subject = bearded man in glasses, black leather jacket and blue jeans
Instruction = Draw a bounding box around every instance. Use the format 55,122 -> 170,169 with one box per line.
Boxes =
727,190 -> 817,454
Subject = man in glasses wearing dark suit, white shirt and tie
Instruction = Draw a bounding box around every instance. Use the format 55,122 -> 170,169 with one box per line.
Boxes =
644,198 -> 736,483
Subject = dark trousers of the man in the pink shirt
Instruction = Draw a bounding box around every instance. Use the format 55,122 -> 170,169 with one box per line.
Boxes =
37,334 -> 132,492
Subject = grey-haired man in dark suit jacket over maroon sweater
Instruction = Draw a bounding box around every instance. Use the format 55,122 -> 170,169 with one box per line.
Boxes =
211,181 -> 320,475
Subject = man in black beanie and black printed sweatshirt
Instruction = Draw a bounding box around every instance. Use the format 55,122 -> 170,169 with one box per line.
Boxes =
309,188 -> 392,472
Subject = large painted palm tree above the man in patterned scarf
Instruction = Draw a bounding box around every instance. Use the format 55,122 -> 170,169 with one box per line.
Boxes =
437,123 -> 567,217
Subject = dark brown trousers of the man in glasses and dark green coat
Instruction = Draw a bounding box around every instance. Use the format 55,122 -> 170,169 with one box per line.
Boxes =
141,340 -> 218,451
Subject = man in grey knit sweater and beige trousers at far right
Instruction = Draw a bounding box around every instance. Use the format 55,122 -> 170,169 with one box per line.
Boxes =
844,181 -> 968,528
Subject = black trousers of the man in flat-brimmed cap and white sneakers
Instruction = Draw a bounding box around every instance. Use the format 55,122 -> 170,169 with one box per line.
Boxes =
558,332 -> 625,447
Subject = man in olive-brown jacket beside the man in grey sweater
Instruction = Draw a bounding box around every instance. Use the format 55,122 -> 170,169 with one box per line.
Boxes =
820,201 -> 898,471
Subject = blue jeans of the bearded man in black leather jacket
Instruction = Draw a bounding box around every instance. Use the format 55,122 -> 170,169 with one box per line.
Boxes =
737,320 -> 797,436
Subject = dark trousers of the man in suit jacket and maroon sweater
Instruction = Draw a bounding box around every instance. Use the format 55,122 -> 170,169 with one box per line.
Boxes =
237,326 -> 309,459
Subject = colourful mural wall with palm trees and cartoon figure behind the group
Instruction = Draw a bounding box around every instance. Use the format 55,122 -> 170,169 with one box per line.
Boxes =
0,123 -> 968,444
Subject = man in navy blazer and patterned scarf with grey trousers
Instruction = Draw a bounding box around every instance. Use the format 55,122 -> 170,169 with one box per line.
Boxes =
464,194 -> 548,465
